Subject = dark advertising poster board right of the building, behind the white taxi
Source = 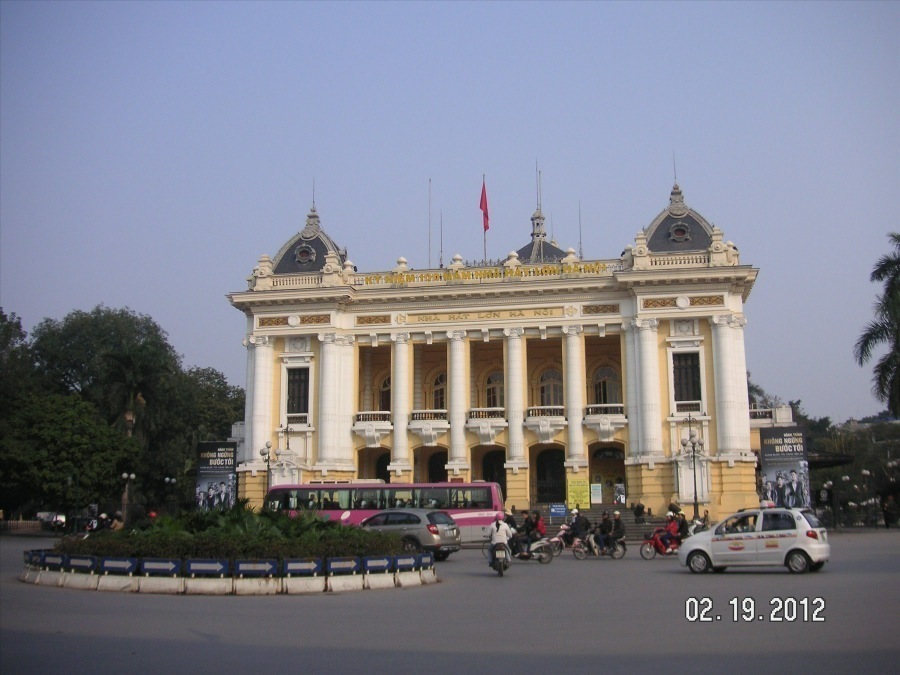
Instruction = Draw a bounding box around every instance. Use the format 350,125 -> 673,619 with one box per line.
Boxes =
759,426 -> 810,508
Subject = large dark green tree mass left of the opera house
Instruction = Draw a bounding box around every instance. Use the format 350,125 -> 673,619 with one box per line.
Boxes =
0,305 -> 244,515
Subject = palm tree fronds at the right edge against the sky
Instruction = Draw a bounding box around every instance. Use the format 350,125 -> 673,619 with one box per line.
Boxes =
853,232 -> 900,417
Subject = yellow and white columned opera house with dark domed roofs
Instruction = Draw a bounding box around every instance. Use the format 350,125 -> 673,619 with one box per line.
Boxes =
229,185 -> 758,517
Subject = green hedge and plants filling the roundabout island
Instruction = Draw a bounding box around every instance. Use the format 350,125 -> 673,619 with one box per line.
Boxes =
55,502 -> 403,560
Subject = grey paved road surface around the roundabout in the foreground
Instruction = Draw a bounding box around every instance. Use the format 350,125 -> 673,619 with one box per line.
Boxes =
0,530 -> 900,675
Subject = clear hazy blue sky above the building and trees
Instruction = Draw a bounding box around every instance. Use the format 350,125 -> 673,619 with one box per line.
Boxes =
0,0 -> 900,421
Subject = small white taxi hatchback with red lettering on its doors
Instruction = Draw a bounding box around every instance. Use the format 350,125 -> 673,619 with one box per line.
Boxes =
678,507 -> 831,574
